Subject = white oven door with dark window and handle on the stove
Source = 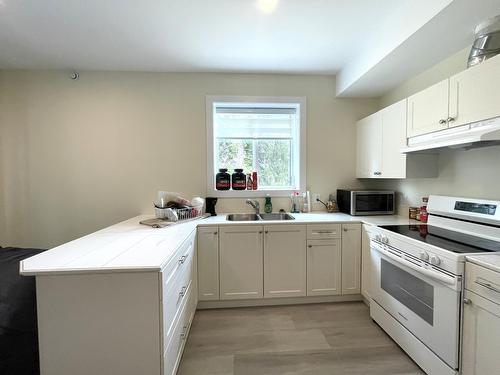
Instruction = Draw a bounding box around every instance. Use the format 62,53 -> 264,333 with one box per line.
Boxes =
370,241 -> 462,369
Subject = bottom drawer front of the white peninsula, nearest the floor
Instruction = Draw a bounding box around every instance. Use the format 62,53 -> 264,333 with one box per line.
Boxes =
163,282 -> 196,375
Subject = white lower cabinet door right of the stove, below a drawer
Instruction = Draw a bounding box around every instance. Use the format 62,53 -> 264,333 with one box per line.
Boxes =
462,290 -> 500,375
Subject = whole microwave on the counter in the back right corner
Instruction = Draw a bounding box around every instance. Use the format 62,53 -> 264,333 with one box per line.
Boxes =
337,189 -> 394,216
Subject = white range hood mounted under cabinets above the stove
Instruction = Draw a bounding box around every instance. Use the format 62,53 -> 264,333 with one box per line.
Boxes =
401,117 -> 500,154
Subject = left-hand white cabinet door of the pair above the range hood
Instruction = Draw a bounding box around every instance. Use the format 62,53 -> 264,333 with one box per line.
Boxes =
407,79 -> 449,137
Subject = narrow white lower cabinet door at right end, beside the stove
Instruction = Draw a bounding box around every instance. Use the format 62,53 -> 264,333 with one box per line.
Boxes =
342,224 -> 361,294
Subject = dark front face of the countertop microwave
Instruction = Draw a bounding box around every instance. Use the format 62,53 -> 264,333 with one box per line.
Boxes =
351,191 -> 394,215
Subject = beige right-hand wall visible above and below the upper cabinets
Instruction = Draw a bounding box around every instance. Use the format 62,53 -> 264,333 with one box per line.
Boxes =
372,48 -> 500,214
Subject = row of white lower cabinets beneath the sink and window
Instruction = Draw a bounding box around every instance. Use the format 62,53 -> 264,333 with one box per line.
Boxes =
198,223 -> 362,306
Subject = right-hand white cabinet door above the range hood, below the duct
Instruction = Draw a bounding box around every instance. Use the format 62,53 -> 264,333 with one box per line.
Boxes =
449,56 -> 500,127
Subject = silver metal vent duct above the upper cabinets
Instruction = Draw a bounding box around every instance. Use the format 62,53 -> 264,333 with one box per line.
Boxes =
467,16 -> 500,68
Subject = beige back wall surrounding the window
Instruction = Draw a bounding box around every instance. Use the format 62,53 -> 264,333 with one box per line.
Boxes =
0,71 -> 378,247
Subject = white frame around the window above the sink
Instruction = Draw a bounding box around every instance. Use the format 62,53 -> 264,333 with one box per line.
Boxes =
205,95 -> 307,198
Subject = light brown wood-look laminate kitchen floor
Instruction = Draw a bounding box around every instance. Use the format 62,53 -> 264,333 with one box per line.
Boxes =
178,302 -> 424,375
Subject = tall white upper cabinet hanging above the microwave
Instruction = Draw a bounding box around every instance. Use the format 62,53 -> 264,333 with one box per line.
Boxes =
356,99 -> 406,178
